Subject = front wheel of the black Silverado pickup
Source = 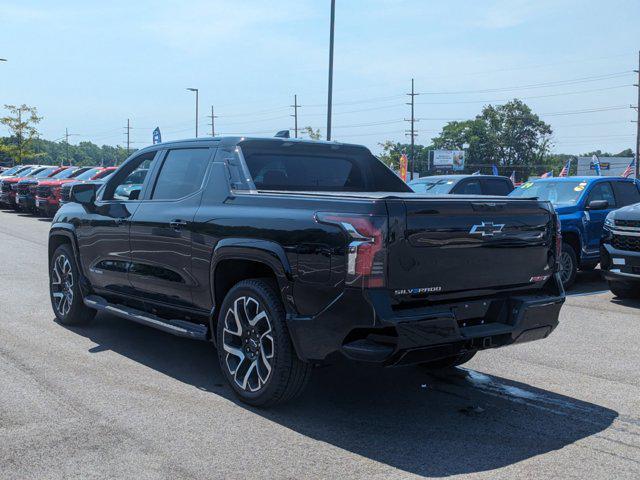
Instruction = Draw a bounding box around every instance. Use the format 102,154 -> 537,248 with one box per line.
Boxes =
49,244 -> 96,325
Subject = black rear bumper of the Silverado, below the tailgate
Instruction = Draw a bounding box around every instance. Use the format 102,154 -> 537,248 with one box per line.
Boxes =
288,275 -> 565,365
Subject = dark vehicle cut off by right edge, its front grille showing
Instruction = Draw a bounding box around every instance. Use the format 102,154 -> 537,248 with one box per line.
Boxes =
600,203 -> 640,298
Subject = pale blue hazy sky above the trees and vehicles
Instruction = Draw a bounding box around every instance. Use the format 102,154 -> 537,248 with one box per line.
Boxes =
0,0 -> 640,154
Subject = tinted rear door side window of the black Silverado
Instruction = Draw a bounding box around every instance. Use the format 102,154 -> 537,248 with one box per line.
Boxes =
151,148 -> 210,200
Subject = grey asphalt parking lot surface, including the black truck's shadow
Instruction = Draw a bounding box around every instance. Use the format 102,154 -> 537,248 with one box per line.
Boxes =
0,210 -> 640,479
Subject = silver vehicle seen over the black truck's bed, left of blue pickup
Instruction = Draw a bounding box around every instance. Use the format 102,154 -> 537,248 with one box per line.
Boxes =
409,175 -> 513,196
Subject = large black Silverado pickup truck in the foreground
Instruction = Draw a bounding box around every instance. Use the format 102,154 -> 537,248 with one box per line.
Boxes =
49,137 -> 564,405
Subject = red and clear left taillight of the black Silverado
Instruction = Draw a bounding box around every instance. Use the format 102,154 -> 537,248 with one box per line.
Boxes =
316,212 -> 387,288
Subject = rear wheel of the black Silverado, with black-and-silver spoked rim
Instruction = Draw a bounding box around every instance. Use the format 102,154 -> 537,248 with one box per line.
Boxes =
216,279 -> 311,407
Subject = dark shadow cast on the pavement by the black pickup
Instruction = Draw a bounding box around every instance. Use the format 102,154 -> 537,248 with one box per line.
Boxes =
62,314 -> 618,477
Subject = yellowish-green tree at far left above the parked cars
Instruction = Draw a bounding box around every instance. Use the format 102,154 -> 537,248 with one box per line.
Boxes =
0,104 -> 42,164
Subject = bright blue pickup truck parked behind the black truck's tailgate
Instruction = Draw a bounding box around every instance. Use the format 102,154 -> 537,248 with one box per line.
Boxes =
509,177 -> 640,288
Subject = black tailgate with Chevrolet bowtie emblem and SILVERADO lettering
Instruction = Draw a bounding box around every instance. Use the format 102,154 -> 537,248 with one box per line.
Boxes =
387,197 -> 555,293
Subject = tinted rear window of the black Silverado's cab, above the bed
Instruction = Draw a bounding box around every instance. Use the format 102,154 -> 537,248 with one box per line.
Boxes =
241,141 -> 411,192
